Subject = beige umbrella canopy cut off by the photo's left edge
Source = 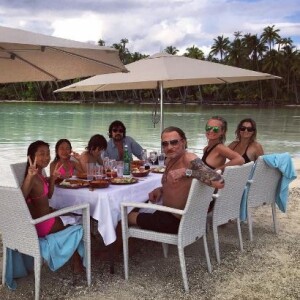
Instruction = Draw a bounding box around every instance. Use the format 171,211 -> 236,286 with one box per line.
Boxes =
0,26 -> 127,83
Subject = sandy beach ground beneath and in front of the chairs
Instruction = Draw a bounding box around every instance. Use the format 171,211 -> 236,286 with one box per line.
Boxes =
0,159 -> 300,300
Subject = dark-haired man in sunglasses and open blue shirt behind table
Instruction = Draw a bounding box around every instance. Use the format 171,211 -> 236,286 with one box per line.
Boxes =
104,120 -> 143,160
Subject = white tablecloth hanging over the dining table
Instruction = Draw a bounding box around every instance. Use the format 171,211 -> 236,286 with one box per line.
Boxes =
50,173 -> 162,245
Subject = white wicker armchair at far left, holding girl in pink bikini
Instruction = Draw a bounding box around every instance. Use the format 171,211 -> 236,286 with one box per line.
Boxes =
0,186 -> 91,299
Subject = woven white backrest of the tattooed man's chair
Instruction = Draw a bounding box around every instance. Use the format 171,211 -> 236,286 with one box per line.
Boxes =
178,179 -> 214,247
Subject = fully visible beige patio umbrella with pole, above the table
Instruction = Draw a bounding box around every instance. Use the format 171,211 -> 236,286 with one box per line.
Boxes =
55,53 -> 280,131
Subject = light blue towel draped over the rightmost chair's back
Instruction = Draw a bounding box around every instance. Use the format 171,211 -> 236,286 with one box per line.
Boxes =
263,153 -> 297,212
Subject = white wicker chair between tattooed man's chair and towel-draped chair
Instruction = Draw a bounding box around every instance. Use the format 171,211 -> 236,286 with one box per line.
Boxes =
212,162 -> 253,264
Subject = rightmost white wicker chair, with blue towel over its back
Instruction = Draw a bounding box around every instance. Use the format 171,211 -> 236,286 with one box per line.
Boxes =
247,156 -> 282,241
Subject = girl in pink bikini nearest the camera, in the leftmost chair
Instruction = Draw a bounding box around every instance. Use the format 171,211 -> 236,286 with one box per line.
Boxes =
22,141 -> 83,273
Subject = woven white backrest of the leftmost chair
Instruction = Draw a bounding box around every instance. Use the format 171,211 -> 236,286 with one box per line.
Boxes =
0,186 -> 40,255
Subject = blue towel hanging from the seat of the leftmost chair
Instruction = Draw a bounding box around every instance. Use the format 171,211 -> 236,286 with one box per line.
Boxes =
5,225 -> 84,290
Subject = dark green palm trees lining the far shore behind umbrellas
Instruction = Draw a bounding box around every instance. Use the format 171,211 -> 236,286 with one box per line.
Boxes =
0,25 -> 300,105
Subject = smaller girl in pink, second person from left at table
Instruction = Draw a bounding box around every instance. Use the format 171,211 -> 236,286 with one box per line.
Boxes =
50,139 -> 83,178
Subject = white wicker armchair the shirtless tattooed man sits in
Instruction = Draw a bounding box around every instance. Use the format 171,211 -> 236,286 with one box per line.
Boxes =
121,179 -> 213,292
